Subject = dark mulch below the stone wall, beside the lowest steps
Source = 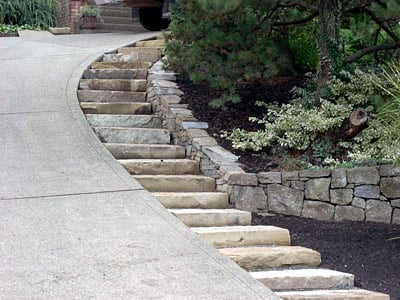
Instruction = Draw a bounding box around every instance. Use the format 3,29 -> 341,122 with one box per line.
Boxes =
253,214 -> 400,300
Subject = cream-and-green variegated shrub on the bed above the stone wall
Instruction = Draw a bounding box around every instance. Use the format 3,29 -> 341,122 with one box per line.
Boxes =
222,70 -> 379,151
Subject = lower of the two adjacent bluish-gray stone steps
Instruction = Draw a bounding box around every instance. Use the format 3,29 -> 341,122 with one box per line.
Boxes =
92,127 -> 170,144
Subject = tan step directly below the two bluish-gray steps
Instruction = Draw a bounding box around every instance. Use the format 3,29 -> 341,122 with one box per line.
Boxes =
104,144 -> 185,159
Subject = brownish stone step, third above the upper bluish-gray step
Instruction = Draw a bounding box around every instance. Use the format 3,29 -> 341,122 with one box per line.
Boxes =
79,79 -> 147,92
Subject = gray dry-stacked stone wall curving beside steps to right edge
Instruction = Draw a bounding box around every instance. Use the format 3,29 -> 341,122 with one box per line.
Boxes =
148,58 -> 400,224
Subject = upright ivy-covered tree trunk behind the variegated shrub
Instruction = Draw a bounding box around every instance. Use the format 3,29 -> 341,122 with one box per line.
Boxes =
317,0 -> 342,103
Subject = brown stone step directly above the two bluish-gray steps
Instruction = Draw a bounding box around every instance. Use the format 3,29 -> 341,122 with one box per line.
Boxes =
80,102 -> 151,115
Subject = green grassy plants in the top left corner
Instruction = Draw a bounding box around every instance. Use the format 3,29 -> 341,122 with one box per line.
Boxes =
0,0 -> 57,29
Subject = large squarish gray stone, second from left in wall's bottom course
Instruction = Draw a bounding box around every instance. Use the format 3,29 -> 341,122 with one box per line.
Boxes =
267,184 -> 304,216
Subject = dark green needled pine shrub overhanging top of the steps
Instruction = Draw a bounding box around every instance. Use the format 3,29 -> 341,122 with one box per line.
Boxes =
167,0 -> 288,106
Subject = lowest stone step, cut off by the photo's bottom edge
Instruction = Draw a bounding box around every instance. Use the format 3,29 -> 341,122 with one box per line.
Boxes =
275,289 -> 390,300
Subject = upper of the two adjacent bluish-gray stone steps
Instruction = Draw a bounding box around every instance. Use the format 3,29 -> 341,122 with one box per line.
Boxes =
86,114 -> 162,128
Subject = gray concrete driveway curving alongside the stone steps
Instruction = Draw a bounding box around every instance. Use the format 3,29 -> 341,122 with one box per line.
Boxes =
0,32 -> 276,299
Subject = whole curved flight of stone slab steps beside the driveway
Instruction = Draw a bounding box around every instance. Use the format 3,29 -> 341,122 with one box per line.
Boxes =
78,38 -> 389,300
